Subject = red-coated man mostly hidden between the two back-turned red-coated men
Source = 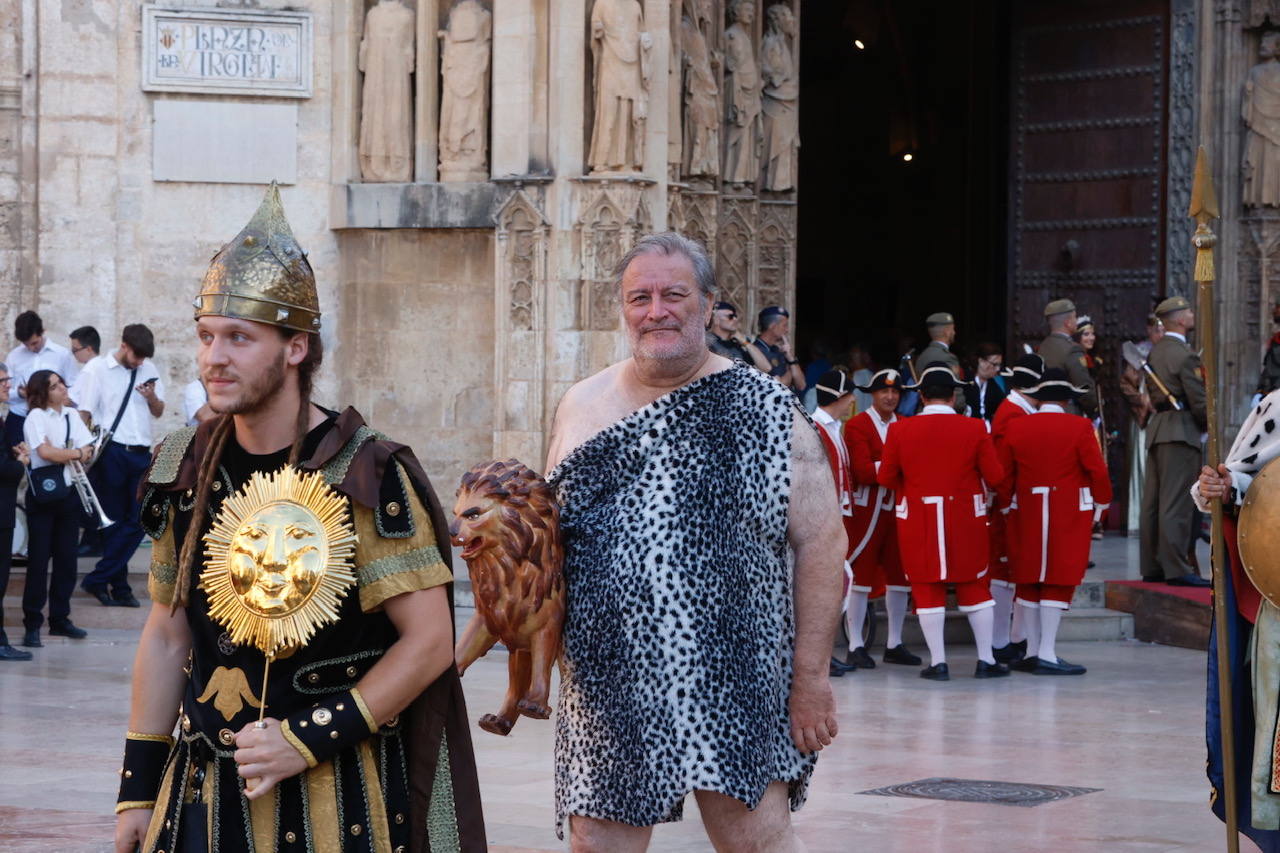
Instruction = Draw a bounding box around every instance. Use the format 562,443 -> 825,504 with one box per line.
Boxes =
991,352 -> 1044,663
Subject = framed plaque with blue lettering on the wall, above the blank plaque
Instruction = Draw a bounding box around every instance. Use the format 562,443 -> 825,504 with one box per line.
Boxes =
142,5 -> 312,97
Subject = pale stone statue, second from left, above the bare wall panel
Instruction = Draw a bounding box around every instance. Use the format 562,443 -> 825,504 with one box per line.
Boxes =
438,0 -> 493,181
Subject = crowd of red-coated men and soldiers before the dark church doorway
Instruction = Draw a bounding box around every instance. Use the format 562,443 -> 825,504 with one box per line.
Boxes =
707,289 -> 1218,679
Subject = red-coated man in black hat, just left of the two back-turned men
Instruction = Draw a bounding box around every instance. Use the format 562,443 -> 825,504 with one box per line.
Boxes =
844,369 -> 920,669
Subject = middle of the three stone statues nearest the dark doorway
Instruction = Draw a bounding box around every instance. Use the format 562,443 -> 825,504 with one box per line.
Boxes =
723,0 -> 760,183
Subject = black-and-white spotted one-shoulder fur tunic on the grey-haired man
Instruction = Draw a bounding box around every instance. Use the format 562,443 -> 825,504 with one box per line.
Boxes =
548,364 -> 815,838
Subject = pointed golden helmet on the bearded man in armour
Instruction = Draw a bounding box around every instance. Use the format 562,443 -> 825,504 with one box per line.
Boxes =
195,181 -> 320,334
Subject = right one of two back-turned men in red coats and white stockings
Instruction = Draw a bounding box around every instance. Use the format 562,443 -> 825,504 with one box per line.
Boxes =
1000,368 -> 1111,675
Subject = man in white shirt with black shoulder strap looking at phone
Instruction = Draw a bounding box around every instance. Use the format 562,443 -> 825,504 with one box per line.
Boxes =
76,323 -> 164,607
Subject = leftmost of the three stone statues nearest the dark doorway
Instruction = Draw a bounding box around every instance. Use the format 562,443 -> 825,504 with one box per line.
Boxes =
680,0 -> 721,177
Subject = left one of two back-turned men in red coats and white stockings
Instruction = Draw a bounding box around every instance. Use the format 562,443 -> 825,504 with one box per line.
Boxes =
878,366 -> 1009,681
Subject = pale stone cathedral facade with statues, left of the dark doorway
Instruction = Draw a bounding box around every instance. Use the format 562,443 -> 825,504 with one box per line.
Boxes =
0,0 -> 800,488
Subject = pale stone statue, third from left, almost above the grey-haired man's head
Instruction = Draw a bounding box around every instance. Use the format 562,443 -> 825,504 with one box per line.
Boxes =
588,0 -> 653,173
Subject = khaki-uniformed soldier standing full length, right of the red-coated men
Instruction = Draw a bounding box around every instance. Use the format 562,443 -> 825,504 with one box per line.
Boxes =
1139,296 -> 1210,587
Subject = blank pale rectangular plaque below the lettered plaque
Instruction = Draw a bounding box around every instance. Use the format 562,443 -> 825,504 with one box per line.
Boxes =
151,100 -> 298,183
